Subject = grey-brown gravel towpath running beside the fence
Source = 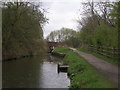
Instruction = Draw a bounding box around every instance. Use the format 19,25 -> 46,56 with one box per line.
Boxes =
71,48 -> 120,83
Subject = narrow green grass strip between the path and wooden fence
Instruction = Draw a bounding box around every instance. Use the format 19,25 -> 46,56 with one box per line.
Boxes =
77,48 -> 120,66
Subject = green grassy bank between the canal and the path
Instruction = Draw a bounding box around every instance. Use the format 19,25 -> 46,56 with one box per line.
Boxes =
54,47 -> 117,89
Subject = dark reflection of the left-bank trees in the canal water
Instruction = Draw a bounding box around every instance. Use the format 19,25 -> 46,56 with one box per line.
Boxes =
2,56 -> 43,88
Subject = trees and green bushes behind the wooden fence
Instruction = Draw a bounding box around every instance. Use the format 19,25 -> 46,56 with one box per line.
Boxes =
78,2 -> 118,47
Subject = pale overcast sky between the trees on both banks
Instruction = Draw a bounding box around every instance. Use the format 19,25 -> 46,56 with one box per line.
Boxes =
40,0 -> 116,38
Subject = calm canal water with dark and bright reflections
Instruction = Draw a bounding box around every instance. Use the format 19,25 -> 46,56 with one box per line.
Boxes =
2,55 -> 70,88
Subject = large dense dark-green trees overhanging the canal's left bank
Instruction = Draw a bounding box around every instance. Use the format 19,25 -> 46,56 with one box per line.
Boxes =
2,2 -> 47,59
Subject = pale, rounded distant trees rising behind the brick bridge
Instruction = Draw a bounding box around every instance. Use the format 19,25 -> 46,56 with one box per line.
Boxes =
47,28 -> 78,46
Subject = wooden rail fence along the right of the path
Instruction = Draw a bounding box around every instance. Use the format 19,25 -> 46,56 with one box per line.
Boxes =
88,45 -> 120,60
